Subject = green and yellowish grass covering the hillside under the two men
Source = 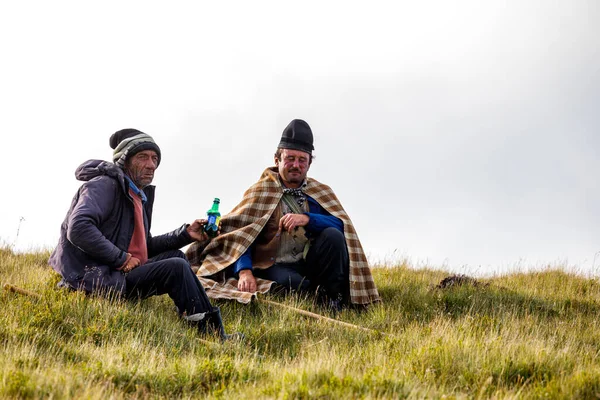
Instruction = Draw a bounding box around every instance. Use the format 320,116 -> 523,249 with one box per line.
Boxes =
0,248 -> 600,399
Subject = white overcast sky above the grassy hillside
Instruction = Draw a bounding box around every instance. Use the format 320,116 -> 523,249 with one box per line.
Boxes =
0,0 -> 600,273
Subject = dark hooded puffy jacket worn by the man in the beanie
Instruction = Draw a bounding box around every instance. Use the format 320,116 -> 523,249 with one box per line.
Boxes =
49,160 -> 192,294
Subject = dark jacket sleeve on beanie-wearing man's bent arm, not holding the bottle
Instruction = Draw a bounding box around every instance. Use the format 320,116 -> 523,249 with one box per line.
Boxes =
67,179 -> 127,268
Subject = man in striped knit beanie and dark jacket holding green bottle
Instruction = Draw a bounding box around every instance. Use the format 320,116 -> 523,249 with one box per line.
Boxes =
49,129 -> 240,339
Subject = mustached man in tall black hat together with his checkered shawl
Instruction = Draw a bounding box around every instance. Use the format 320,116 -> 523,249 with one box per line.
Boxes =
187,119 -> 379,310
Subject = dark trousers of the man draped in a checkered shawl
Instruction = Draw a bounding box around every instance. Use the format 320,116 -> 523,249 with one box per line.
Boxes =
253,228 -> 350,302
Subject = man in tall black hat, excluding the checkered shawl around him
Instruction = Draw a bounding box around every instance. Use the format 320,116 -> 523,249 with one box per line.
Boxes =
233,119 -> 349,309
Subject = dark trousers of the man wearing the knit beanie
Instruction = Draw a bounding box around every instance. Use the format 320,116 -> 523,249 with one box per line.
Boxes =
125,250 -> 212,316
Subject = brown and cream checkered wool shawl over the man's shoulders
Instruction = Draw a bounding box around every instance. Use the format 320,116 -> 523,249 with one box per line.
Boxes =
187,167 -> 380,304
